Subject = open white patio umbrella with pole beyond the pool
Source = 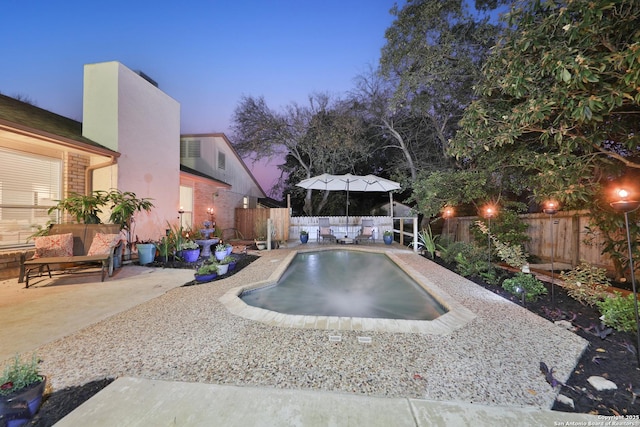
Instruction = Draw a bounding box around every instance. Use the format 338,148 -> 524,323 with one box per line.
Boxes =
296,173 -> 400,234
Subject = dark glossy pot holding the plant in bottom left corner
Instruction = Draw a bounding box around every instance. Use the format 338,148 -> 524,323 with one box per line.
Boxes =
0,377 -> 46,427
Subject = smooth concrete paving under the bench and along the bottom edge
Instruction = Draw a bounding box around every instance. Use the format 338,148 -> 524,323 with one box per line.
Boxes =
0,246 -> 606,426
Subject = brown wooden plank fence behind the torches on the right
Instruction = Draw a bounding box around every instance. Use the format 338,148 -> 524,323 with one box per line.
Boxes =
442,211 -> 615,272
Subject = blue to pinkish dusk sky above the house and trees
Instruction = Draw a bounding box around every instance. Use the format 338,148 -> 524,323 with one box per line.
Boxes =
0,0 -> 404,196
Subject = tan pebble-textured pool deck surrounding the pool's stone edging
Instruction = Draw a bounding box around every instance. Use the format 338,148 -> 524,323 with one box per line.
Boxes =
31,250 -> 586,408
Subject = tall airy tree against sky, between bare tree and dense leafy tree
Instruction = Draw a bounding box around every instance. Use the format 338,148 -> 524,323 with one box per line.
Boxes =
378,0 -> 502,188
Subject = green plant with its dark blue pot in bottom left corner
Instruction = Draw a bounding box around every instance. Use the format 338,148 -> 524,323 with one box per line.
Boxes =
0,354 -> 46,426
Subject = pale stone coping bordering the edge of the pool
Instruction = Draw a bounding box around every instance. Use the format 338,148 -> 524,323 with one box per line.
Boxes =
219,247 -> 476,335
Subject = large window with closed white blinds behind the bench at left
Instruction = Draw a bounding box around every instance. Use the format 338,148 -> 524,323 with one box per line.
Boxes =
0,149 -> 62,247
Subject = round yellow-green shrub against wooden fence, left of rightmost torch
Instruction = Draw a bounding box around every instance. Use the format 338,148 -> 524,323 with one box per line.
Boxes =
560,261 -> 611,306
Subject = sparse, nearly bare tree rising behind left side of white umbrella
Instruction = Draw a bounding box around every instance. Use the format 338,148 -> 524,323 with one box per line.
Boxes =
232,94 -> 369,215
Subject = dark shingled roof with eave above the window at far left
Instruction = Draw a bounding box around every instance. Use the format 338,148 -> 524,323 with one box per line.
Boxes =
0,94 -> 119,156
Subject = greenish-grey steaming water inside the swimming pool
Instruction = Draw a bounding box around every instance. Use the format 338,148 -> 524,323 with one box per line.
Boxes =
240,250 -> 447,320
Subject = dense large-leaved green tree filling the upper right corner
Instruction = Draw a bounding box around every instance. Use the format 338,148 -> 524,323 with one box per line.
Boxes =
450,0 -> 640,206
